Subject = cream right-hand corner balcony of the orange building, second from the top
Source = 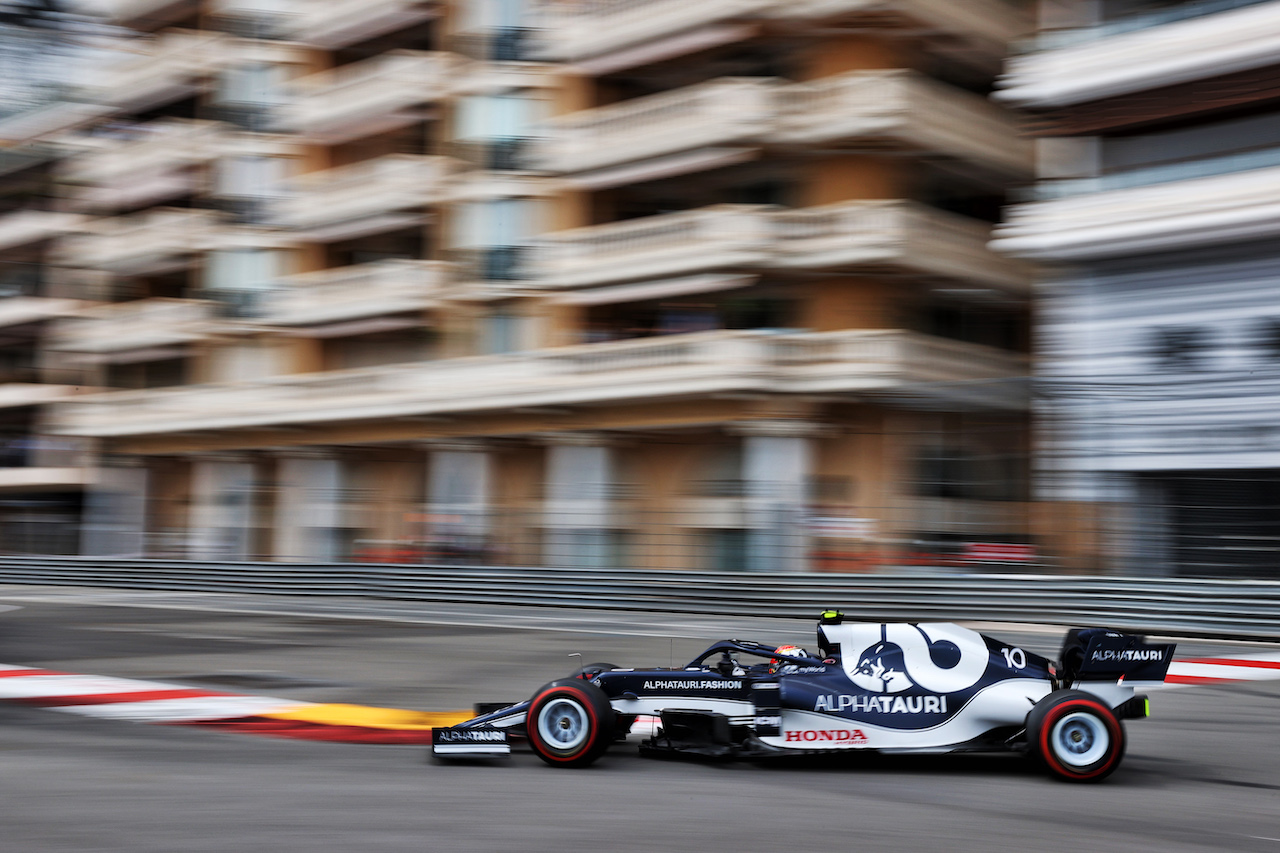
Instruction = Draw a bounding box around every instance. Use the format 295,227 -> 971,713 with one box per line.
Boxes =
773,69 -> 1034,178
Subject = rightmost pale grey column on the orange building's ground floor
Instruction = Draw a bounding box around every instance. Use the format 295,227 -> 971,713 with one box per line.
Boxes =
736,419 -> 817,571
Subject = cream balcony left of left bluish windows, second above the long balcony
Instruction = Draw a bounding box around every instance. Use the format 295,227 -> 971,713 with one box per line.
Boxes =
60,207 -> 218,275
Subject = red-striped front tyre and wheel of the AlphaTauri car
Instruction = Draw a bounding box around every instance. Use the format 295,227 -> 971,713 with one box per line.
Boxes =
525,679 -> 616,767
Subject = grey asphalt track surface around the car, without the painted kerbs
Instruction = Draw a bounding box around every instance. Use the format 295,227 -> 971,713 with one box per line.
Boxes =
0,587 -> 1280,853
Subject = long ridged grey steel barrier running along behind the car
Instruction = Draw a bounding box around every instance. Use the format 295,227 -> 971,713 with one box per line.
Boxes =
0,557 -> 1280,640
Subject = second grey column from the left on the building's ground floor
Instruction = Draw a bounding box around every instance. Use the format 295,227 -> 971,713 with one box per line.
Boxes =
187,453 -> 255,561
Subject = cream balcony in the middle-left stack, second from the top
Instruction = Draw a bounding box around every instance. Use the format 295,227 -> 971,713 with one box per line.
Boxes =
280,50 -> 462,145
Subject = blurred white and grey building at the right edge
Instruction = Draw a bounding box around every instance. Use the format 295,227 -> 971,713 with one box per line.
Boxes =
993,0 -> 1280,576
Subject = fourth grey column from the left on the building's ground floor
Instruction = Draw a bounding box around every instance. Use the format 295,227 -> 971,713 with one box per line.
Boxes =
426,442 -> 493,562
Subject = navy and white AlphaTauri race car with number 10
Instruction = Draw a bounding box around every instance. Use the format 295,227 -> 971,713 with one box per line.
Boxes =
431,611 -> 1174,781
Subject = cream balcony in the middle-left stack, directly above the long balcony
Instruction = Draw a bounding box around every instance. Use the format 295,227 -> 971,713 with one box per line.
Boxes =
261,260 -> 449,325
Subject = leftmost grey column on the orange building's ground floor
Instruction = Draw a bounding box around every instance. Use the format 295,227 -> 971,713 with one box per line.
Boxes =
79,456 -> 150,557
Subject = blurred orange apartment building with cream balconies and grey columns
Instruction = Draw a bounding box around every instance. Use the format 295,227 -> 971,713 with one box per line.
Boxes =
0,0 -> 1033,570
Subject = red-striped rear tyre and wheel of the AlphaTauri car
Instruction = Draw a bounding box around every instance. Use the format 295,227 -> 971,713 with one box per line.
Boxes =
1027,690 -> 1125,783
